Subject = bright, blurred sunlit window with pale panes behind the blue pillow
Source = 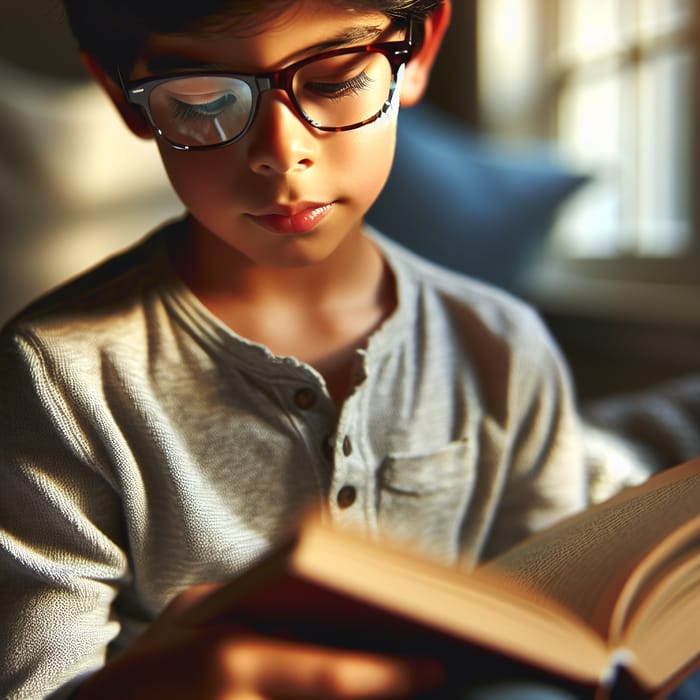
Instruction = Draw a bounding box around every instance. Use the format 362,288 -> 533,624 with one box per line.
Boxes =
478,0 -> 700,306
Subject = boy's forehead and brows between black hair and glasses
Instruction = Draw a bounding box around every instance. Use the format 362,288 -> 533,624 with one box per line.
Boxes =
137,0 -> 390,74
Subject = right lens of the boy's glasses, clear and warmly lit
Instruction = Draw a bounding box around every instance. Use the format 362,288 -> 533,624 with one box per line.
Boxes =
293,51 -> 393,128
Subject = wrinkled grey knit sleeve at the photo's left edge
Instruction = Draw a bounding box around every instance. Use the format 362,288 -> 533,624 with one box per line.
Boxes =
0,330 -> 128,698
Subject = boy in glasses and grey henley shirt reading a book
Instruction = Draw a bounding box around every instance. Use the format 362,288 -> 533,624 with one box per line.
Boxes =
0,0 -> 585,700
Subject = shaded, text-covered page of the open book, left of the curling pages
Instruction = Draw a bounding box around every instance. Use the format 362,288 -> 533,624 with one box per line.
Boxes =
483,459 -> 700,638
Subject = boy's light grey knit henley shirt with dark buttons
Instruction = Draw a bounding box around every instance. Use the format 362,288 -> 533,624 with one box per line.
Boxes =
0,223 -> 586,698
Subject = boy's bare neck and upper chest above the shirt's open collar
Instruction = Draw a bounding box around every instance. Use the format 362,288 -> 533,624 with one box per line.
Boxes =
175,217 -> 396,404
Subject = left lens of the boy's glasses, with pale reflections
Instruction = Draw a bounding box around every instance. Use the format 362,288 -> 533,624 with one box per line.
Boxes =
149,76 -> 253,146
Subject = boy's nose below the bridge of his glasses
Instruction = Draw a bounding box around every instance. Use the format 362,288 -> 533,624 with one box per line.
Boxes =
248,90 -> 318,175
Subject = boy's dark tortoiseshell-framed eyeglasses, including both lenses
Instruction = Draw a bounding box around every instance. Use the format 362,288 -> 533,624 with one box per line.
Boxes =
124,21 -> 415,150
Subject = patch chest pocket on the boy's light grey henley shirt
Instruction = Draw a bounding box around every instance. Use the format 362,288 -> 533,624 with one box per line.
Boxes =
378,439 -> 475,562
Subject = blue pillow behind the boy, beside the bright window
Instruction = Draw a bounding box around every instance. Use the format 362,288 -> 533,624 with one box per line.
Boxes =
367,105 -> 588,289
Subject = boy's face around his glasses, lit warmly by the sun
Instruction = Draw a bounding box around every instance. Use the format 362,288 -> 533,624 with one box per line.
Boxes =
93,0 -> 448,267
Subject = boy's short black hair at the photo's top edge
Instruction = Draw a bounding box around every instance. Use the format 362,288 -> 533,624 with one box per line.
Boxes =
63,0 -> 443,75
